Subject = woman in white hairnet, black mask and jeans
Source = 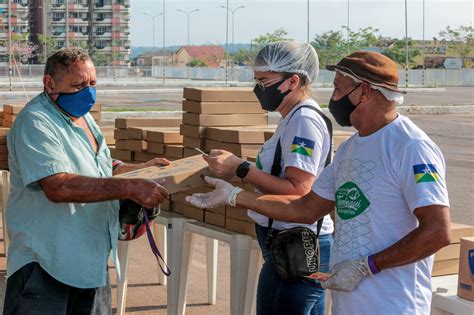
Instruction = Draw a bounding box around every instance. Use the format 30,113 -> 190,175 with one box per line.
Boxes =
204,42 -> 334,314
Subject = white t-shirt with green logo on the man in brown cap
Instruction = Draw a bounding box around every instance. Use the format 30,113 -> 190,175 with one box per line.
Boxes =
313,114 -> 449,315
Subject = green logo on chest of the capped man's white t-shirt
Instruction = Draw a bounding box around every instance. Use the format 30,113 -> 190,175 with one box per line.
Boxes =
336,182 -> 370,220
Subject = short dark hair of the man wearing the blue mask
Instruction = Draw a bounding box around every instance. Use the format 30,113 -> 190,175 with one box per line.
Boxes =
44,48 -> 91,79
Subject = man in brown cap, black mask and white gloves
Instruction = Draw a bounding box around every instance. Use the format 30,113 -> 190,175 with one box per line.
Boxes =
188,52 -> 451,314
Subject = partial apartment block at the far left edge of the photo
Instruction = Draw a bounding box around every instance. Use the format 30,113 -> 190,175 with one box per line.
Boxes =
0,0 -> 29,63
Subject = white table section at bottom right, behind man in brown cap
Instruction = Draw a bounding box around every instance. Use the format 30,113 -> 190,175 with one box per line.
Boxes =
431,275 -> 474,315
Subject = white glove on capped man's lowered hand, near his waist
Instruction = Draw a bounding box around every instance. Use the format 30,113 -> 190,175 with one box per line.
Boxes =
321,257 -> 373,291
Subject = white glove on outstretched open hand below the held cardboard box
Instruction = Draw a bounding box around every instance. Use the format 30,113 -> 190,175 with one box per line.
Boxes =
186,176 -> 242,208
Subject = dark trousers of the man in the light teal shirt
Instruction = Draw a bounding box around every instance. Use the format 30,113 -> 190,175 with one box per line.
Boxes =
3,263 -> 112,315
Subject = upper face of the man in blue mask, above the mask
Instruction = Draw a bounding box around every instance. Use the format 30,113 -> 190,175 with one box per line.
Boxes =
43,60 -> 97,100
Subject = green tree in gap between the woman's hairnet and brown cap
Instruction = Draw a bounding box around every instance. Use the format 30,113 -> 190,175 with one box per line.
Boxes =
311,31 -> 347,68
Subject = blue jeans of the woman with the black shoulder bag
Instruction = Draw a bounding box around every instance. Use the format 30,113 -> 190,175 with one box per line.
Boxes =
255,224 -> 333,315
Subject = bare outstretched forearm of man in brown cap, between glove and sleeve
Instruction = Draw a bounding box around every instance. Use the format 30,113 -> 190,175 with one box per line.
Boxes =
236,191 -> 334,224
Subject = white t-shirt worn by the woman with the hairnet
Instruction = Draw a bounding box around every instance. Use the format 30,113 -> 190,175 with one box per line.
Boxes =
248,99 -> 334,235
